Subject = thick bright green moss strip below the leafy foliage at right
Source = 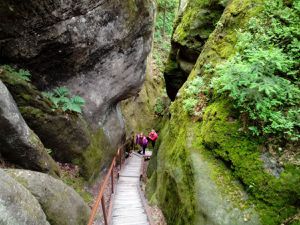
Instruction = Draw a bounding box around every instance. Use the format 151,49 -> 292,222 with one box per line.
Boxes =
199,100 -> 300,224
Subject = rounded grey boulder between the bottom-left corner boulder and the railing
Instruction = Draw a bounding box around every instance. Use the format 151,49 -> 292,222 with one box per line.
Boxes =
6,169 -> 90,225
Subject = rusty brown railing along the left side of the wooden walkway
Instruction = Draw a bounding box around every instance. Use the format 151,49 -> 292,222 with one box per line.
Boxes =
88,147 -> 123,225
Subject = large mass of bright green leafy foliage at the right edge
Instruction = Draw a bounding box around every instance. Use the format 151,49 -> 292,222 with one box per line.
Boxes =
212,0 -> 300,140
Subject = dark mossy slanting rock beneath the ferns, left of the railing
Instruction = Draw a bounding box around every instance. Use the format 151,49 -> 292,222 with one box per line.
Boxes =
0,66 -> 115,180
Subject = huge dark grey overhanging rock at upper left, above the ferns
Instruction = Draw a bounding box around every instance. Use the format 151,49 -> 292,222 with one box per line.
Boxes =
0,0 -> 154,142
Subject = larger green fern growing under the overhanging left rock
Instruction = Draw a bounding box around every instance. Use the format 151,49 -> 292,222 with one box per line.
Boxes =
43,87 -> 85,113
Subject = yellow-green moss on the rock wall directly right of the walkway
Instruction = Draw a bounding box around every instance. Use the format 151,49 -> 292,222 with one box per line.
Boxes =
147,115 -> 195,224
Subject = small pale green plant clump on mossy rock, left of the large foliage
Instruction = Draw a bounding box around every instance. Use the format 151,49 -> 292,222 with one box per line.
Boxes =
183,77 -> 204,116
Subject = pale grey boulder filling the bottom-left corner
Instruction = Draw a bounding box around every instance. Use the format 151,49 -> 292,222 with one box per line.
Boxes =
0,169 -> 50,225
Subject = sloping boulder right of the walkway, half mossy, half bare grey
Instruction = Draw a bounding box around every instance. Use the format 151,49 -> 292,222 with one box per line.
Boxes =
147,105 -> 261,225
